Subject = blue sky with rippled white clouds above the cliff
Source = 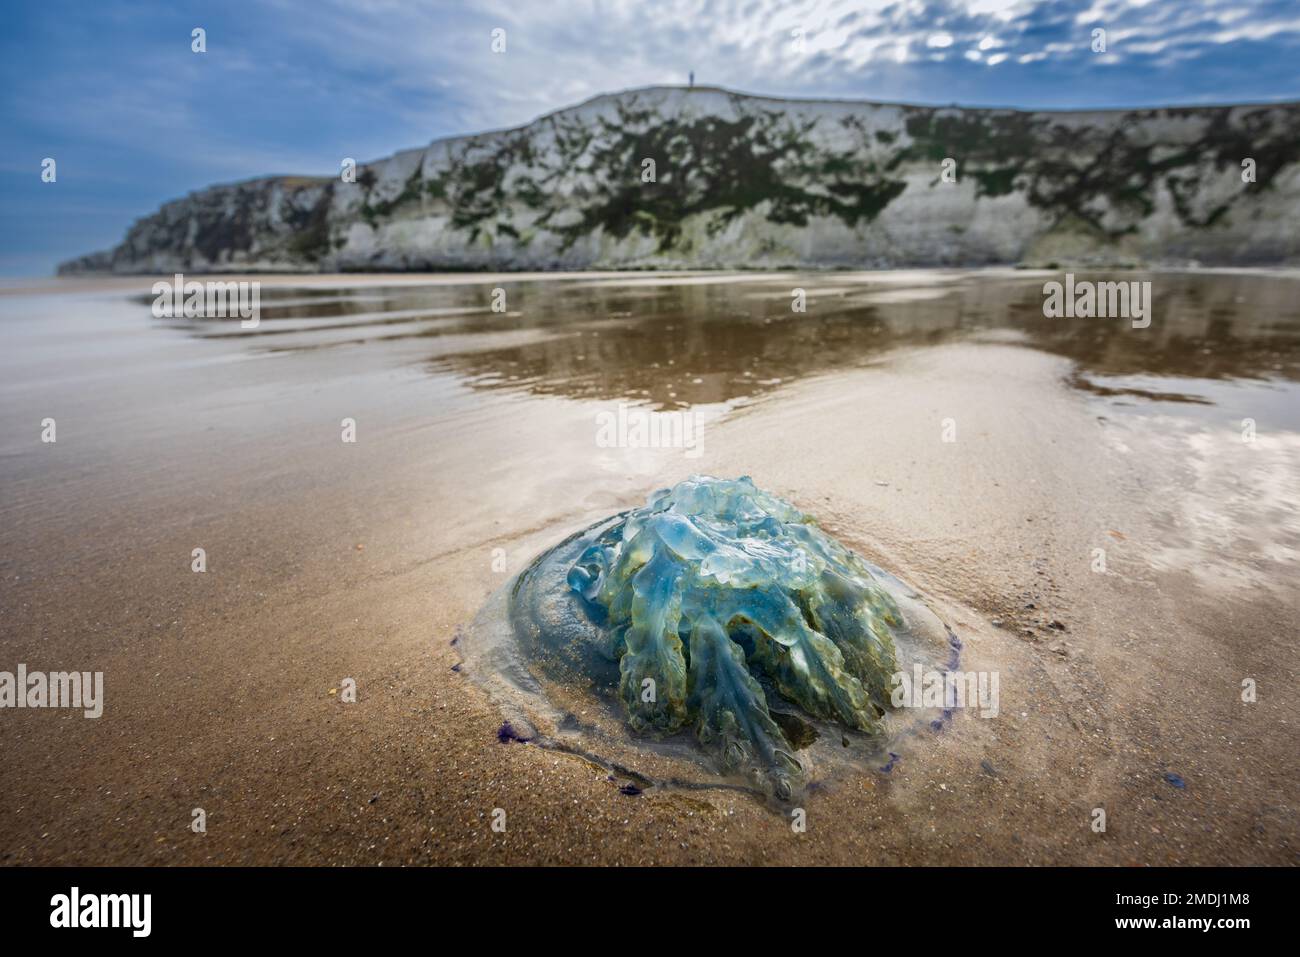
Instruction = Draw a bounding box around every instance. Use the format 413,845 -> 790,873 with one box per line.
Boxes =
0,0 -> 1300,276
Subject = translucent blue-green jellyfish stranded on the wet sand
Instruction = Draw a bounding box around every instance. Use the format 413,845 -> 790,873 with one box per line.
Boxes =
471,476 -> 958,800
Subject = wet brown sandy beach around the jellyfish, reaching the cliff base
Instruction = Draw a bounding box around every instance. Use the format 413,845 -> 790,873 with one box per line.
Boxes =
0,270 -> 1300,865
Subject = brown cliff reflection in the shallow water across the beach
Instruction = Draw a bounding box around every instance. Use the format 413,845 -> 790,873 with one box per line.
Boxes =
149,272 -> 1300,408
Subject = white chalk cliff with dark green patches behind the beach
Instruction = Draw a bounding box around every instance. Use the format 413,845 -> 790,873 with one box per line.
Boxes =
60,87 -> 1300,273
